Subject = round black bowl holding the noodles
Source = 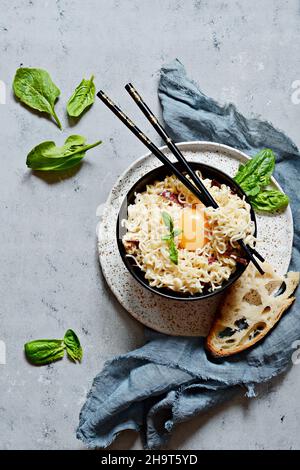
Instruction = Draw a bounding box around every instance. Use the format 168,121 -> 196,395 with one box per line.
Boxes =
117,162 -> 257,300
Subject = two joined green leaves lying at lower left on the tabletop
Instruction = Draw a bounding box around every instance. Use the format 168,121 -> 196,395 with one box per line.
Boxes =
24,330 -> 83,366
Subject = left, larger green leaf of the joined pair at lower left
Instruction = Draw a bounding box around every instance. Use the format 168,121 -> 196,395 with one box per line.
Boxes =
24,339 -> 65,366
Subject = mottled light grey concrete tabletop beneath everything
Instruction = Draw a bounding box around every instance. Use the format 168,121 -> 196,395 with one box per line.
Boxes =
0,0 -> 300,449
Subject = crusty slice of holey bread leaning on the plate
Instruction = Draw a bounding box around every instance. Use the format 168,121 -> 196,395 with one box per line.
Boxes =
206,262 -> 299,357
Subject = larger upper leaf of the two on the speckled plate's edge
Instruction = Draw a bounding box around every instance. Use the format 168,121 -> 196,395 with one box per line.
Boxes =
234,149 -> 275,196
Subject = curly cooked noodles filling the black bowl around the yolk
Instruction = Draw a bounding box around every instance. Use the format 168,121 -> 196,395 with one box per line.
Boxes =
122,172 -> 255,294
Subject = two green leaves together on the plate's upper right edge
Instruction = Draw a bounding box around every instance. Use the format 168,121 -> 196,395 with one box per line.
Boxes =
234,149 -> 289,212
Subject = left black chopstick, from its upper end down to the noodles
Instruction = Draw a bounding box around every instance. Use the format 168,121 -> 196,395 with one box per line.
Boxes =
97,90 -> 207,206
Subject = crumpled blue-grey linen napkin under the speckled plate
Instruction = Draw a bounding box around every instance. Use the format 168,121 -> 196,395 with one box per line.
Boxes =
77,60 -> 300,449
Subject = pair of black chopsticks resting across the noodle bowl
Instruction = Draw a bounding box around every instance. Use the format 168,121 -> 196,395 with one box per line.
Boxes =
97,83 -> 264,274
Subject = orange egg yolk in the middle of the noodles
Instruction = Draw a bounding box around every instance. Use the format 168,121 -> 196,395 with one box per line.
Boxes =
178,204 -> 207,251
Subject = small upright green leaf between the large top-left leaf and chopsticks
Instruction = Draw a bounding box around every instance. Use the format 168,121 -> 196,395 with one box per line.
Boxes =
67,75 -> 96,117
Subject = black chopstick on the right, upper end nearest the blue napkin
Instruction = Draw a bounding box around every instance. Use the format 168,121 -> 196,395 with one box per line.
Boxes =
125,83 -> 264,274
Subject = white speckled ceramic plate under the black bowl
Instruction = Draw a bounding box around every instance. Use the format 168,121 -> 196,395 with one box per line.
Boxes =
97,142 -> 293,336
